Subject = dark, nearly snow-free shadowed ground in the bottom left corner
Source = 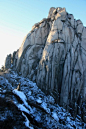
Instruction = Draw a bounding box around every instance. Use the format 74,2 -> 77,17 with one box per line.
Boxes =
0,96 -> 25,129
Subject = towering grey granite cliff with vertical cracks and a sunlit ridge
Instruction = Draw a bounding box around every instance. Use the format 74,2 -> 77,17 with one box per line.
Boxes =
5,7 -> 86,120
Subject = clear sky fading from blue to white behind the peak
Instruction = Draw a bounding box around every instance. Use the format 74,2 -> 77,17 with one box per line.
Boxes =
0,0 -> 86,67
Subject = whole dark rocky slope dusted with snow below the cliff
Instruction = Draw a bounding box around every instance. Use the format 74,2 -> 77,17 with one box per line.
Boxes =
0,70 -> 86,129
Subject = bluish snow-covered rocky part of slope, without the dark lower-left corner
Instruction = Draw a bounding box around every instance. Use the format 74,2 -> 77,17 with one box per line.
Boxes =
0,71 -> 86,129
